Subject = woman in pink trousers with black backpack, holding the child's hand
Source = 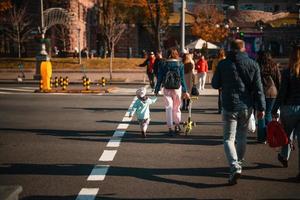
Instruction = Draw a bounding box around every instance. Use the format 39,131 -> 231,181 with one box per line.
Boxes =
154,49 -> 189,136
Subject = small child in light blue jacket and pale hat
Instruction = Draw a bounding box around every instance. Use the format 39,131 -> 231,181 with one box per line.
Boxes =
129,88 -> 157,137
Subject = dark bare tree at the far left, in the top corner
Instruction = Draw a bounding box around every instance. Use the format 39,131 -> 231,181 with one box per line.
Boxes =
5,5 -> 32,58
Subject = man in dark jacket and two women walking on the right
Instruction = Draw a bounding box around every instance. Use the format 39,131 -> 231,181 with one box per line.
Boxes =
212,40 -> 300,185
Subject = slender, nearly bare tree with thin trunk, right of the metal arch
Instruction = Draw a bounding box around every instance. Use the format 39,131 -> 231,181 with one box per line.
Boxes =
103,0 -> 127,80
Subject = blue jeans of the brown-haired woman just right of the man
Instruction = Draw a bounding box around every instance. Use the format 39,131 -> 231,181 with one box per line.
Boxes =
257,98 -> 276,142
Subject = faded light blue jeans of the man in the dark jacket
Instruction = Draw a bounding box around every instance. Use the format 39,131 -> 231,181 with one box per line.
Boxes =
223,109 -> 252,172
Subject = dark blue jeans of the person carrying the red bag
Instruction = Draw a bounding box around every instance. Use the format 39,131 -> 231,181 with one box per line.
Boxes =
280,105 -> 300,172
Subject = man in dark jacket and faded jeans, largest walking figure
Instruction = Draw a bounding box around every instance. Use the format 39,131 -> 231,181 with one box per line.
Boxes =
212,40 -> 265,185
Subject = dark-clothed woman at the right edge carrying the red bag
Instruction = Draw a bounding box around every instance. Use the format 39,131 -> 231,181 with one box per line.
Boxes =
272,44 -> 300,181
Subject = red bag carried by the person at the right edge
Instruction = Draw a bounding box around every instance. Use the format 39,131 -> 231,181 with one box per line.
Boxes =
267,121 -> 289,147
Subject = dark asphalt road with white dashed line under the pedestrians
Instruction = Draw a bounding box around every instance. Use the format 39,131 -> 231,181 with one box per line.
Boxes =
0,86 -> 300,200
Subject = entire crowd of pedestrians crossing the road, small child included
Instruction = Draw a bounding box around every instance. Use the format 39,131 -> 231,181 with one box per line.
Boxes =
131,40 -> 300,185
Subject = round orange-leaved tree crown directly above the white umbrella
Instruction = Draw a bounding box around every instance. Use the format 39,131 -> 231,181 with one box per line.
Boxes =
191,5 -> 229,42
